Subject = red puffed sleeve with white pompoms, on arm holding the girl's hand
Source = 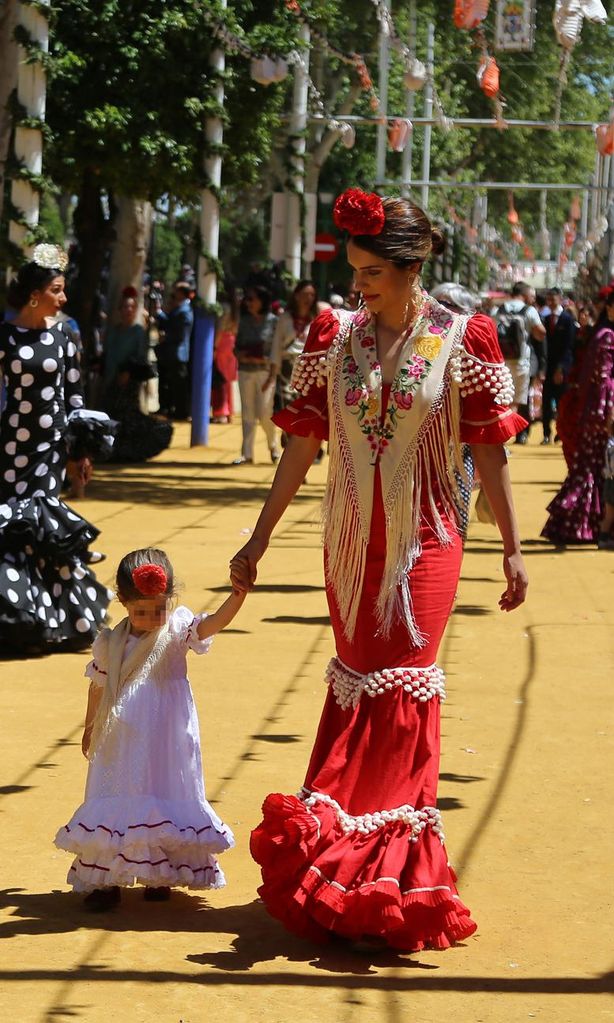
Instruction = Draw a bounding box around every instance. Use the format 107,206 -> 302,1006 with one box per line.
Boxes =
273,309 -> 340,441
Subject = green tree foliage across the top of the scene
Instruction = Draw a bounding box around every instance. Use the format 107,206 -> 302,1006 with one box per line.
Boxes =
31,0 -> 612,319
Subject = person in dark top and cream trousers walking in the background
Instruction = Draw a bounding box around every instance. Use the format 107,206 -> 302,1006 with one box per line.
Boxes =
233,284 -> 279,465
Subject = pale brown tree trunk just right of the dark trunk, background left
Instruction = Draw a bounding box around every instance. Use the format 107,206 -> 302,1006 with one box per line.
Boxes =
108,195 -> 152,323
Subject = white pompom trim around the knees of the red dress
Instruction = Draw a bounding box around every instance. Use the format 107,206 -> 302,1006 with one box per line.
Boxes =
324,657 -> 445,710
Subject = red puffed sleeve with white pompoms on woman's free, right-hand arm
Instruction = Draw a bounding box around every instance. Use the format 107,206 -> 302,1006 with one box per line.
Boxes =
454,313 -> 527,444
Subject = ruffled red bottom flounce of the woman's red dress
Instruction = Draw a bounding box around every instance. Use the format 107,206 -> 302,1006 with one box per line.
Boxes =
251,795 -> 477,951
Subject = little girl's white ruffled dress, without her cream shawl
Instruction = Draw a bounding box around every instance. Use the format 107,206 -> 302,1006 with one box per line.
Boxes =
55,608 -> 234,892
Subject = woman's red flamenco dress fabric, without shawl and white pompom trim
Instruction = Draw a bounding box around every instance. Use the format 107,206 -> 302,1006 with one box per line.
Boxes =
251,304 -> 524,949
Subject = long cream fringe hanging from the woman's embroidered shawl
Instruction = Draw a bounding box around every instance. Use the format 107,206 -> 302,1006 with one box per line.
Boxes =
323,308 -> 467,647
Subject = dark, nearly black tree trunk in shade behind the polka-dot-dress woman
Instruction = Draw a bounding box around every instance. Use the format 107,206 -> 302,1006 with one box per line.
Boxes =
70,169 -> 113,359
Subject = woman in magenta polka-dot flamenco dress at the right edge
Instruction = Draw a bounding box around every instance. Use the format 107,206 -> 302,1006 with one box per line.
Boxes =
541,287 -> 614,544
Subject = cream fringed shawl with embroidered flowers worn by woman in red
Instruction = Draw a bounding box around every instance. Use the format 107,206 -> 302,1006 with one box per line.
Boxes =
313,298 -> 468,646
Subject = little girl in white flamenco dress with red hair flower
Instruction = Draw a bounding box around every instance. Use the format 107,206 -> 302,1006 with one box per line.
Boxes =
55,548 -> 244,911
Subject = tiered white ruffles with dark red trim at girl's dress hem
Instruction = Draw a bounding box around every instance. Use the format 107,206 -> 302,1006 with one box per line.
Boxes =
55,796 -> 234,892
